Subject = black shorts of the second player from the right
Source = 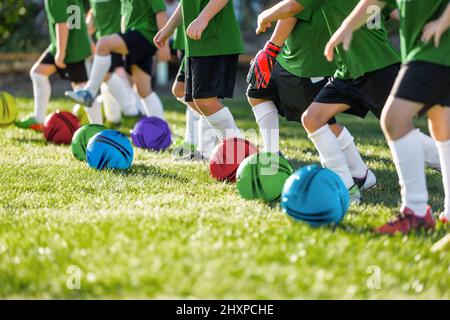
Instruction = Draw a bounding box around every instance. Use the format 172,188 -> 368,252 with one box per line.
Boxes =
314,64 -> 400,118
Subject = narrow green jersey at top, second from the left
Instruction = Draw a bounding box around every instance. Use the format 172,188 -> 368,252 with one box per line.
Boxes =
90,0 -> 122,39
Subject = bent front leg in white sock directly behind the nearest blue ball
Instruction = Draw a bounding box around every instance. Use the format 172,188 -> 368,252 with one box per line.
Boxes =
302,102 -> 355,189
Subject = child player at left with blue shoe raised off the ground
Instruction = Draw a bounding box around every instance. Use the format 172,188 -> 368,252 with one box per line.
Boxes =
66,0 -> 170,118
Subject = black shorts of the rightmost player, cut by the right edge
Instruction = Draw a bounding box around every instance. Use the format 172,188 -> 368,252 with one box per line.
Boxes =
392,61 -> 450,114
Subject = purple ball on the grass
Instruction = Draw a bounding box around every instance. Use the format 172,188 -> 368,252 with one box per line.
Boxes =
131,117 -> 172,151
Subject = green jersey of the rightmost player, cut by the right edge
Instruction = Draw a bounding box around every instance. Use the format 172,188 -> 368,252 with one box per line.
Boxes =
384,0 -> 450,66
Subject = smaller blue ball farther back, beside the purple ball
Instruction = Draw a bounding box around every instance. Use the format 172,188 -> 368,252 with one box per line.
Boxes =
86,130 -> 134,170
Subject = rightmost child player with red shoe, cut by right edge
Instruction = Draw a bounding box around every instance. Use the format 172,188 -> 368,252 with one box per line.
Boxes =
326,0 -> 450,234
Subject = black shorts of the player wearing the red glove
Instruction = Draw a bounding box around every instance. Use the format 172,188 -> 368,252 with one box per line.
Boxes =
247,63 -> 336,124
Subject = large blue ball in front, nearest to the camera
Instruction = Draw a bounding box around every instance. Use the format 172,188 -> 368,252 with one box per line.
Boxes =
281,165 -> 350,227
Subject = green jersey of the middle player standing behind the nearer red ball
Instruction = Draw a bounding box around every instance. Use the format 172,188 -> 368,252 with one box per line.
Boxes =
181,0 -> 244,57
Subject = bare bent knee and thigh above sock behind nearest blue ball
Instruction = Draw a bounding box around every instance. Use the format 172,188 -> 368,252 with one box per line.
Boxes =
302,102 -> 350,133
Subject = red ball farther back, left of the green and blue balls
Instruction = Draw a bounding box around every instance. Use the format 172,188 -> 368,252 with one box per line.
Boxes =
44,111 -> 80,144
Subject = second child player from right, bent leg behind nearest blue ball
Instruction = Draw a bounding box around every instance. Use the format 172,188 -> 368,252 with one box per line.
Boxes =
257,0 -> 439,202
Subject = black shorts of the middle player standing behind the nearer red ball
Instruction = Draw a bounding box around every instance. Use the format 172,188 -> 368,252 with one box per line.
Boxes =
186,54 -> 239,102
